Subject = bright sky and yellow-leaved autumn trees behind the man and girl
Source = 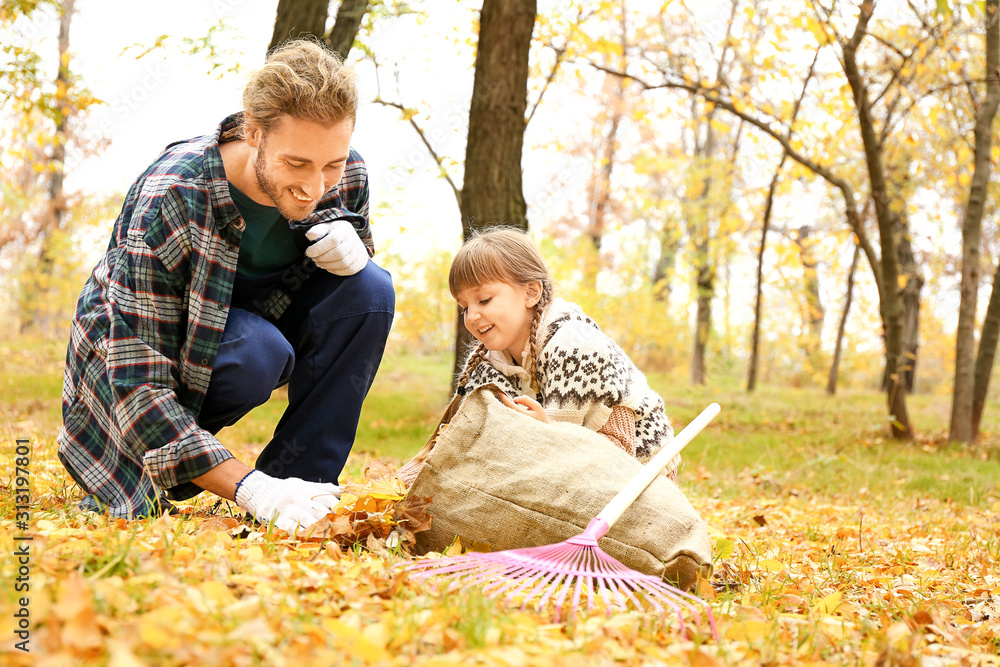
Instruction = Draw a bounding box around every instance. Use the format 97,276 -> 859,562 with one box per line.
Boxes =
0,0 -> 1000,442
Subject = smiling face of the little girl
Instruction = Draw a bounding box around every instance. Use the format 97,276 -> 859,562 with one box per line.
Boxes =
455,281 -> 542,363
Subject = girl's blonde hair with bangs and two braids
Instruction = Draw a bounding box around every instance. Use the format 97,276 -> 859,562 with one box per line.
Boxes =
448,227 -> 553,402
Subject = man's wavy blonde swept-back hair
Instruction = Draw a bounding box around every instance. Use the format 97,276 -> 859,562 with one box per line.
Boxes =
243,39 -> 358,134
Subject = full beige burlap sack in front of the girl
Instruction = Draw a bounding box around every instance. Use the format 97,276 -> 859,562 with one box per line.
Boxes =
409,385 -> 712,589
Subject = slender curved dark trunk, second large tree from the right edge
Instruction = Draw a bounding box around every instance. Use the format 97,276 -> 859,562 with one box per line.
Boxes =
843,0 -> 913,440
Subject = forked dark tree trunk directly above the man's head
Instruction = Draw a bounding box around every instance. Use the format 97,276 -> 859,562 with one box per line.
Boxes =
267,0 -> 368,60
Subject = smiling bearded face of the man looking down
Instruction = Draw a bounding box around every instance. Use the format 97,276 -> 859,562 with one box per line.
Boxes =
246,116 -> 354,220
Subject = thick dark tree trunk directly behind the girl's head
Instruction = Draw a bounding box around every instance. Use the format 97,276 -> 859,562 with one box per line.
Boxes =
455,0 -> 536,386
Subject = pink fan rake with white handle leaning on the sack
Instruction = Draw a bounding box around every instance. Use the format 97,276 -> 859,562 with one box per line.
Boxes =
406,403 -> 721,639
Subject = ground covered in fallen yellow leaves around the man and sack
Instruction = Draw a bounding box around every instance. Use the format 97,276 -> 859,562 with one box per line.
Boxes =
0,348 -> 1000,667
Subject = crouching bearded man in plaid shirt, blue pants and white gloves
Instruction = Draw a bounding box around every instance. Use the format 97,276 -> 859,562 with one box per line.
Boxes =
58,40 -> 394,530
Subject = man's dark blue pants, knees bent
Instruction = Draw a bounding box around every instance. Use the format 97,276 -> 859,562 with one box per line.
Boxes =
198,262 -> 395,483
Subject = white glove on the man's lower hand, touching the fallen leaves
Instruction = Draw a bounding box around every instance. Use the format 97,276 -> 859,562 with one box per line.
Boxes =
236,470 -> 340,533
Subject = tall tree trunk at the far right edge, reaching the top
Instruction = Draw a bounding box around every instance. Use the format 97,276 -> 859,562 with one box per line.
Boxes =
948,0 -> 1000,442
